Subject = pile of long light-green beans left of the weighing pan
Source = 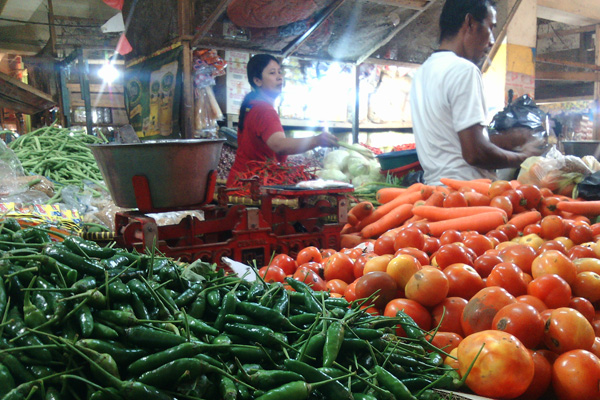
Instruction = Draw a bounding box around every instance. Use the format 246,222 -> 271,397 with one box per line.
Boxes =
8,125 -> 106,203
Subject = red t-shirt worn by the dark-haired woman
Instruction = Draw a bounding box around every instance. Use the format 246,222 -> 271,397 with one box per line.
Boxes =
227,100 -> 287,187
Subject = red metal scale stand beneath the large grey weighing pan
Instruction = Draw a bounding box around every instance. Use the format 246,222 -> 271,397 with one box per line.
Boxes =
115,171 -> 354,267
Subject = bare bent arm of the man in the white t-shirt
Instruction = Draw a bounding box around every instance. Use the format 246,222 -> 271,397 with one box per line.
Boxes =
458,125 -> 543,169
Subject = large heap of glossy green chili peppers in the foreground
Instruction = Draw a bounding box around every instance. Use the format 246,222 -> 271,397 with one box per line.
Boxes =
0,218 -> 462,400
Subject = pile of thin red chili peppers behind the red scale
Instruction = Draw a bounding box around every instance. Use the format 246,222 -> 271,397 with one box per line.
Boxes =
230,160 -> 317,197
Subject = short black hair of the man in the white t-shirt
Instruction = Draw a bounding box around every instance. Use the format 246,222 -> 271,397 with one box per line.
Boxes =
440,0 -> 496,42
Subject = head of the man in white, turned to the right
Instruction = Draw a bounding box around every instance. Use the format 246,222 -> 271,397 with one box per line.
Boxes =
440,0 -> 496,63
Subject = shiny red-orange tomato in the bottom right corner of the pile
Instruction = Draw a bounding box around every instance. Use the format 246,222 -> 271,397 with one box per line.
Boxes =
552,350 -> 600,400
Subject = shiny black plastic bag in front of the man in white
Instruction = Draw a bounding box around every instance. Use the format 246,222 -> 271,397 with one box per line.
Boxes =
490,89 -> 546,131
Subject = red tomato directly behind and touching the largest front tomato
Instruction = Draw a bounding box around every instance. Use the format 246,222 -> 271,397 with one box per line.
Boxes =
492,301 -> 544,349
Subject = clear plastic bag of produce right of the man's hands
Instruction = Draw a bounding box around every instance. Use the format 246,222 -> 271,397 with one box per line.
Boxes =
517,146 -> 592,197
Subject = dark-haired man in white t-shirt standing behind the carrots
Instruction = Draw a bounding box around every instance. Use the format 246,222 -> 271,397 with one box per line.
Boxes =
410,0 -> 543,185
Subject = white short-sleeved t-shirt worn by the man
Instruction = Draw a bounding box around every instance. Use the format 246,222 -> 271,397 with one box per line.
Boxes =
410,51 -> 494,185
